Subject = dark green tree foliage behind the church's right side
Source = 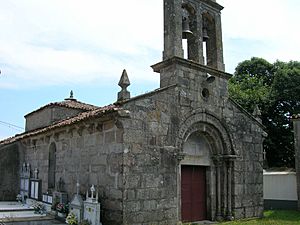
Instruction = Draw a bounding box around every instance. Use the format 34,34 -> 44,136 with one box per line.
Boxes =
229,58 -> 300,167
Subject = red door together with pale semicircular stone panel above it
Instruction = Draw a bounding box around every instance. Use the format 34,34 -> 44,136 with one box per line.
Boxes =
181,132 -> 211,222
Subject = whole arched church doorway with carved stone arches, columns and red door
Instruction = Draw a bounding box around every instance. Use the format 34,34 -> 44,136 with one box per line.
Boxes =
177,112 -> 236,222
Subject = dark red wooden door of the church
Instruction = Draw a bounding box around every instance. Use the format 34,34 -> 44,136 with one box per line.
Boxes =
181,166 -> 206,222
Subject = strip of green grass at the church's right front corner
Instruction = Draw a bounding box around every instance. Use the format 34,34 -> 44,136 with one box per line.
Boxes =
219,210 -> 300,225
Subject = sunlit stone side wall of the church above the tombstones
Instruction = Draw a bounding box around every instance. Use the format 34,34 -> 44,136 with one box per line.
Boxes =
19,118 -> 123,225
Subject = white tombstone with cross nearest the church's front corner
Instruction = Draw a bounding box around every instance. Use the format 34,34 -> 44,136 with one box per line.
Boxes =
83,185 -> 102,225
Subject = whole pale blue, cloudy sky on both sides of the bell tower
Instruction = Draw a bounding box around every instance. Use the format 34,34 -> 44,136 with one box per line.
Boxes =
0,0 -> 300,139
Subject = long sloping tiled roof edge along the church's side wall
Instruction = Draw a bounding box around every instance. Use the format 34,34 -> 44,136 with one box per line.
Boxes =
0,105 -> 122,145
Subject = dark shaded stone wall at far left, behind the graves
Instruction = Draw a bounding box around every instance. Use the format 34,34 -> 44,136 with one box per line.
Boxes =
0,144 -> 20,201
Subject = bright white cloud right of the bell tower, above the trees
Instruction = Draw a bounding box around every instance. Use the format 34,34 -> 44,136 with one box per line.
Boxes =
218,0 -> 300,71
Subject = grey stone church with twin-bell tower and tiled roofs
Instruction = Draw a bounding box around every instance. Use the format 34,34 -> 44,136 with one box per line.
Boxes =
0,0 -> 265,225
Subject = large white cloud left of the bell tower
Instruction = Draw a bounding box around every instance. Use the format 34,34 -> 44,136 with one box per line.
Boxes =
0,0 -> 162,88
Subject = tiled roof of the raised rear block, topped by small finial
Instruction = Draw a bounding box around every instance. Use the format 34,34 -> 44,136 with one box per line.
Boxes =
25,99 -> 99,117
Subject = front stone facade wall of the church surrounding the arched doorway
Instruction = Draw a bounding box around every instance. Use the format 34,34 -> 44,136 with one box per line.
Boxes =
122,59 -> 263,225
